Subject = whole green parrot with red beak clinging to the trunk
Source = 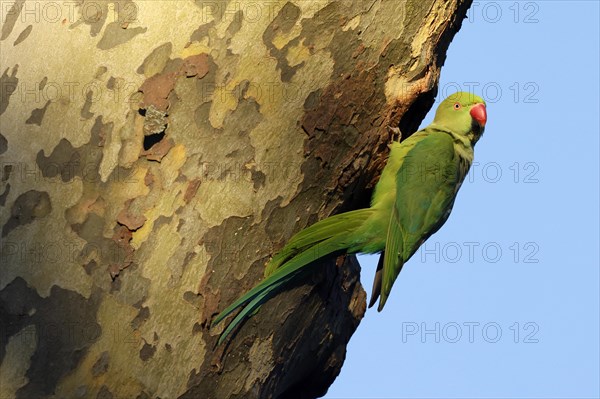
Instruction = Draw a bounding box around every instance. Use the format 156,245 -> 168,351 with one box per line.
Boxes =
212,92 -> 487,344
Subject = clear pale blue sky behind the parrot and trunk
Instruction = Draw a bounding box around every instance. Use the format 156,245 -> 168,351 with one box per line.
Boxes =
325,1 -> 600,399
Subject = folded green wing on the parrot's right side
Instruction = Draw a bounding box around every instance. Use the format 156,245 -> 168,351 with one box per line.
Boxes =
374,130 -> 464,310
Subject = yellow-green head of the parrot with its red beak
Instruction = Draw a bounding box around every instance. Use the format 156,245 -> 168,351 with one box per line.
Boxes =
433,91 -> 487,145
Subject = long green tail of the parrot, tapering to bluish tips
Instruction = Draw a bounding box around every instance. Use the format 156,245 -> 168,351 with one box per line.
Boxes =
212,208 -> 373,344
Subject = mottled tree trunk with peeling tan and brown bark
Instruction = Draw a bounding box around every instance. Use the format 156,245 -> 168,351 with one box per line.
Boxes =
0,0 -> 470,398
